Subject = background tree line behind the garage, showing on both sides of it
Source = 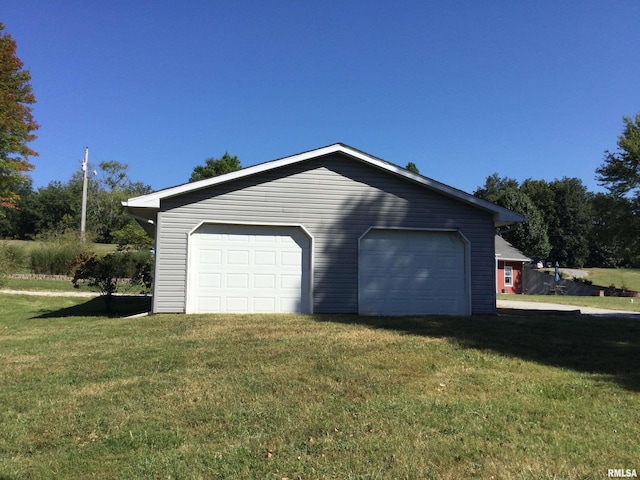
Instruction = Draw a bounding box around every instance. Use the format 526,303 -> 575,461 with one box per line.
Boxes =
0,114 -> 640,267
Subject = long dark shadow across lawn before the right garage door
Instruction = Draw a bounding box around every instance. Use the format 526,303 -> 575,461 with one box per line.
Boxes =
316,315 -> 640,391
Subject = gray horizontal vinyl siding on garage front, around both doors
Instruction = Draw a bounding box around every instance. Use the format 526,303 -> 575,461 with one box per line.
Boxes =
154,154 -> 495,313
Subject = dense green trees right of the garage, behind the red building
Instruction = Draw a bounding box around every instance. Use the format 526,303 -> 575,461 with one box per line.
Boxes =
474,114 -> 640,268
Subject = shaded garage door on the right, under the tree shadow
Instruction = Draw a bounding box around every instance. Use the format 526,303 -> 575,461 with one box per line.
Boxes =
358,229 -> 471,315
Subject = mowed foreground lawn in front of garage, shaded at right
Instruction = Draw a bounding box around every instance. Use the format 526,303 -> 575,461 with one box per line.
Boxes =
0,295 -> 640,480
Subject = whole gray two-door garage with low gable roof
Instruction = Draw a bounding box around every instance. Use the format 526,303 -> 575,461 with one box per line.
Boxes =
125,144 -> 523,315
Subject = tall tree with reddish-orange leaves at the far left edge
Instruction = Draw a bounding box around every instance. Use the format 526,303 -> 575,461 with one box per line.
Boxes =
0,23 -> 39,208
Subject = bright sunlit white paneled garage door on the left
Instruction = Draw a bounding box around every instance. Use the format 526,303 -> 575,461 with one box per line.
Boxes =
187,224 -> 310,313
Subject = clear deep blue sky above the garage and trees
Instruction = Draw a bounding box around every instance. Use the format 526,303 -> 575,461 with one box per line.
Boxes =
5,0 -> 640,192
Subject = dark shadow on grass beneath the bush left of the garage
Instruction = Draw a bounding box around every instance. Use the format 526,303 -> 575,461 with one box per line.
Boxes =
34,295 -> 151,318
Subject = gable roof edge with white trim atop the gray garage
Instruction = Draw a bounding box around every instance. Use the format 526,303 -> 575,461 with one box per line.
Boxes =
122,143 -> 524,226
